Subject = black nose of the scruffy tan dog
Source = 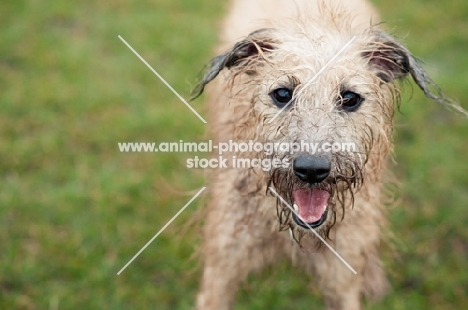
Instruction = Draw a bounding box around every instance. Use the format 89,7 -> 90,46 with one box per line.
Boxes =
293,155 -> 331,184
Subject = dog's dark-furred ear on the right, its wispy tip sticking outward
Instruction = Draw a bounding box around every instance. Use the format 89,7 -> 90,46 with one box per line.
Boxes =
363,29 -> 468,116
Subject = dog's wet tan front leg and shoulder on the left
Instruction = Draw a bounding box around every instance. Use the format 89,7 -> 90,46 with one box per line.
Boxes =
197,172 -> 281,310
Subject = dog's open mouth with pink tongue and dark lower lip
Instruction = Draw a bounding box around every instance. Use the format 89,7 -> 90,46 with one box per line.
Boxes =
292,188 -> 330,229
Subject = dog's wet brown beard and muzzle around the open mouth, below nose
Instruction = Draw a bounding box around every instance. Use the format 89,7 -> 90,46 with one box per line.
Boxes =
267,153 -> 364,245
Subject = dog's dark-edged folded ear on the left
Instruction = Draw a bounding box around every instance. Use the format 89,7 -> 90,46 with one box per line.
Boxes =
191,29 -> 275,100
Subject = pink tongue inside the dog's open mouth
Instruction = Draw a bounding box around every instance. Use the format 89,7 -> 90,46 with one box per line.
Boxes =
293,189 -> 330,223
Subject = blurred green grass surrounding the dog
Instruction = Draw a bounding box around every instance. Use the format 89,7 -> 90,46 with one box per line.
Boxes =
0,0 -> 468,310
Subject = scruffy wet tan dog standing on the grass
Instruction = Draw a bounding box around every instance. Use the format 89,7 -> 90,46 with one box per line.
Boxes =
190,0 -> 461,310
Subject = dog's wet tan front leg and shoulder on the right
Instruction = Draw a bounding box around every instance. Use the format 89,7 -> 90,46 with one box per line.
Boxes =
296,196 -> 388,310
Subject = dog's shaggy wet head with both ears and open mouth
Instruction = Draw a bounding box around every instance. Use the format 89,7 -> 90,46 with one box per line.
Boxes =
194,24 -> 455,240
